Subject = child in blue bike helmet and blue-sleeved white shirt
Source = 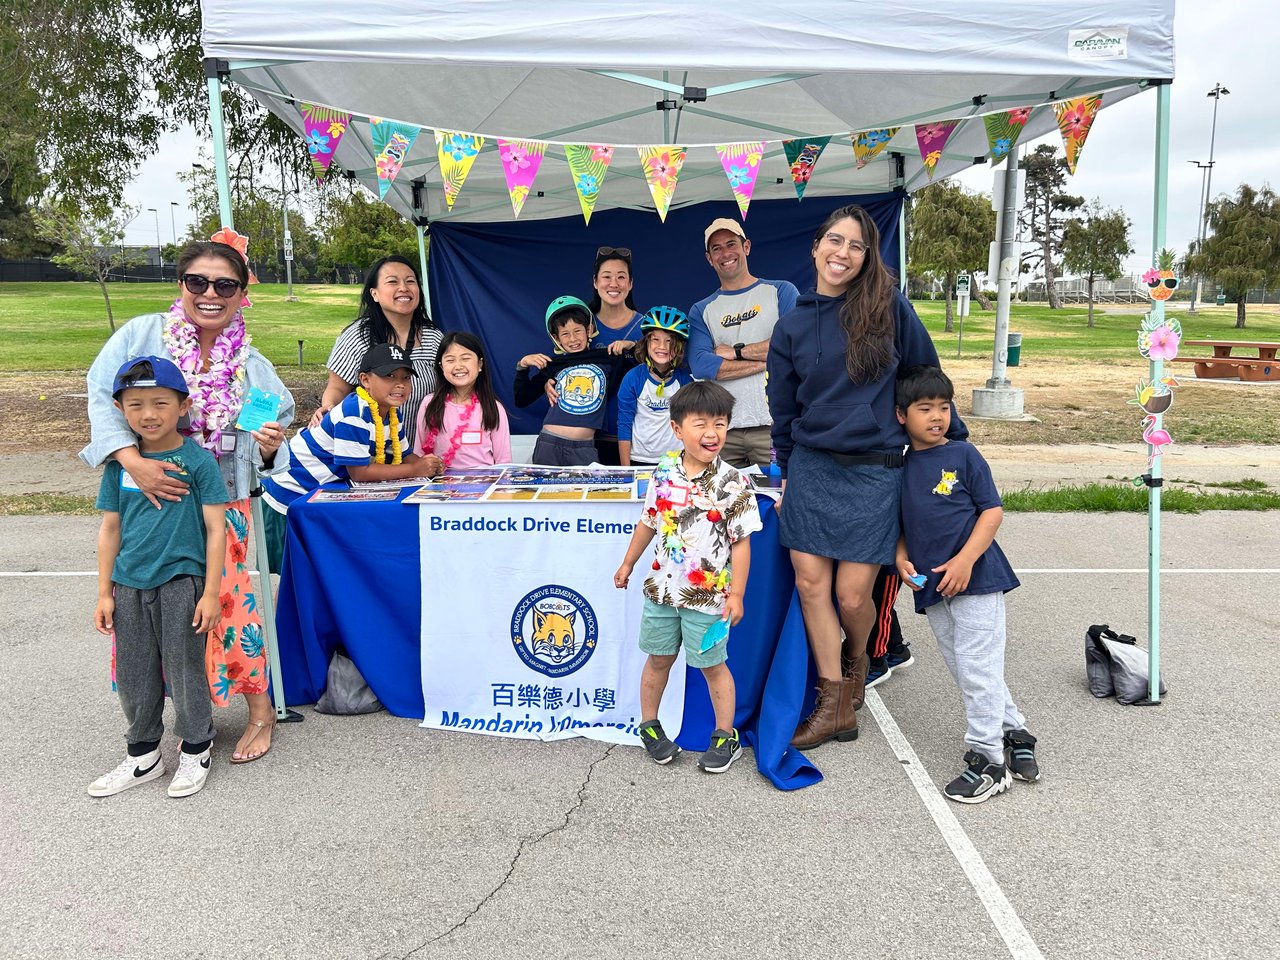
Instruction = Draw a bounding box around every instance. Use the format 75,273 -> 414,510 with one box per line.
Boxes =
618,307 -> 694,466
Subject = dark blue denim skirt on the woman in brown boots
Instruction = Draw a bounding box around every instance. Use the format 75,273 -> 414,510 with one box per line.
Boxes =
778,445 -> 902,566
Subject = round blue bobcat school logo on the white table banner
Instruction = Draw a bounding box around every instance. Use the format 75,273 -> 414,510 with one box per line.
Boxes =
511,584 -> 598,677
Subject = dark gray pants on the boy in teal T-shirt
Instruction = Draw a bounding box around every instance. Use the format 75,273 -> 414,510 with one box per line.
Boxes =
115,576 -> 214,744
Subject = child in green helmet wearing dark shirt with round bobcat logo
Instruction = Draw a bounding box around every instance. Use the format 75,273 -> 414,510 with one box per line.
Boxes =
512,297 -> 630,467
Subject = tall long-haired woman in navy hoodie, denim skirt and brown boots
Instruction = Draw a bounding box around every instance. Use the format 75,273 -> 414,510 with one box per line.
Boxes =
768,205 -> 968,749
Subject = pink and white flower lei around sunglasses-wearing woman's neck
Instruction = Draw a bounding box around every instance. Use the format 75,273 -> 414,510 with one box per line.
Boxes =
163,300 -> 250,458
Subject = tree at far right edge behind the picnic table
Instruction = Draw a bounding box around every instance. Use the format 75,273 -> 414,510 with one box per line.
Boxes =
1187,183 -> 1280,330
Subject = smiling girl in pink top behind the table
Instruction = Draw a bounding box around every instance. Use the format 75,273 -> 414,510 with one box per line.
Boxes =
413,330 -> 511,470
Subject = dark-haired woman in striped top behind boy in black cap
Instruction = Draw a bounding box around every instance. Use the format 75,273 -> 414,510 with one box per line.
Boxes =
310,256 -> 443,445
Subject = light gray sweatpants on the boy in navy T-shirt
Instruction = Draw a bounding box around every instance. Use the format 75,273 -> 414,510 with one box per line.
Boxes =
924,593 -> 1027,763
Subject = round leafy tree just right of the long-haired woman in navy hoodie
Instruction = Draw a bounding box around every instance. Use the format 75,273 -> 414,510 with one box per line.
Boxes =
908,180 -> 996,333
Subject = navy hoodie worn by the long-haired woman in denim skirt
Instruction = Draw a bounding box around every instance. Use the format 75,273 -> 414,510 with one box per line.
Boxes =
767,291 -> 969,476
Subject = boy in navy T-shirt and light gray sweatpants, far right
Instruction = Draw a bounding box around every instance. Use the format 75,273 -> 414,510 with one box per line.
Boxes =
896,366 -> 1039,804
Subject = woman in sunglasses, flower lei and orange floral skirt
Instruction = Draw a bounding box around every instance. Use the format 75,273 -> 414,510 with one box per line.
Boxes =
79,239 -> 293,763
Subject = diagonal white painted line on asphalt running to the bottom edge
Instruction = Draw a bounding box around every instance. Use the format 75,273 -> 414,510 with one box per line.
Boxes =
865,690 -> 1044,960
